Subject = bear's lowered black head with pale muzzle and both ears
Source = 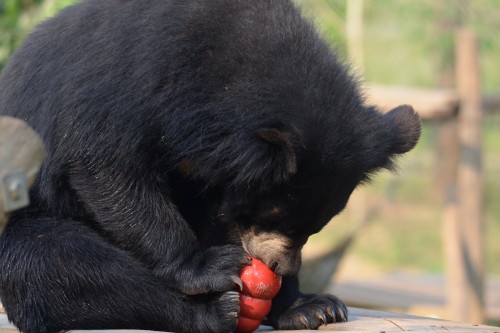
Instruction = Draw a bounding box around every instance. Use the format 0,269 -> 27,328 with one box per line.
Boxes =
219,105 -> 421,275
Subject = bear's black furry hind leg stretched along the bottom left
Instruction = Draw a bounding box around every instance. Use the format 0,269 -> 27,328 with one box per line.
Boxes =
0,216 -> 239,333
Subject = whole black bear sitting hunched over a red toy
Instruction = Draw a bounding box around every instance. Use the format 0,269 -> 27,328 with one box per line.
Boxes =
0,0 -> 420,333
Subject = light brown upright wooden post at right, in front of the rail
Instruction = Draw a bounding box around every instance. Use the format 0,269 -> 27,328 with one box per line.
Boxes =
447,29 -> 484,323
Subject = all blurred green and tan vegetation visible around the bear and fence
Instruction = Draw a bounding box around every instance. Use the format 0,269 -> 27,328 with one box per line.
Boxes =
0,0 -> 500,275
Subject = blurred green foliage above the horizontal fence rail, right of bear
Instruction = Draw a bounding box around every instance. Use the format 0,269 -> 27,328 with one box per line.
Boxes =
295,0 -> 500,92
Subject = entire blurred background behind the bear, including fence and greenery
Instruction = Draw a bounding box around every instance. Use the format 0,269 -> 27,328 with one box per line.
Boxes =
0,0 -> 500,325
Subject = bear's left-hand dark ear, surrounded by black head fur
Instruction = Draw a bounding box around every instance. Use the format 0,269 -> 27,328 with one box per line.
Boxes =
257,127 -> 301,175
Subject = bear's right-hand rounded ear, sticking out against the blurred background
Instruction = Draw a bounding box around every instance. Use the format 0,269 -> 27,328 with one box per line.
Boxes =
383,105 -> 422,154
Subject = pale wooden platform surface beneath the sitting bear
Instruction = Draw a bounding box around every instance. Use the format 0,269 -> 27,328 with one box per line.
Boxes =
0,308 -> 500,333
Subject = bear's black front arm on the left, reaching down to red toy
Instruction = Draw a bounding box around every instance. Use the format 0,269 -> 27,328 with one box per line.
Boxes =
70,158 -> 248,295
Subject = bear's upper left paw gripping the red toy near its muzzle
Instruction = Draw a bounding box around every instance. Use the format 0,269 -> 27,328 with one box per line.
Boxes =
181,245 -> 250,295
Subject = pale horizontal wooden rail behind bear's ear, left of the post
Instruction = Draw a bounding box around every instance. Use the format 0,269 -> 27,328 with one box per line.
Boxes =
366,85 -> 459,120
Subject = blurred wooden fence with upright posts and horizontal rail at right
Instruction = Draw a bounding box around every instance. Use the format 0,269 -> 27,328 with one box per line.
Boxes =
367,29 -> 500,322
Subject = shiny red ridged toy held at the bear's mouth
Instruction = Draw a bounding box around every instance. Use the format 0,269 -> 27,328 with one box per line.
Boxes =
236,258 -> 281,333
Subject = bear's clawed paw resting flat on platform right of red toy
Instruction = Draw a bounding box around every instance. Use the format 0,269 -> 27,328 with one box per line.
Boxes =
275,295 -> 347,330
